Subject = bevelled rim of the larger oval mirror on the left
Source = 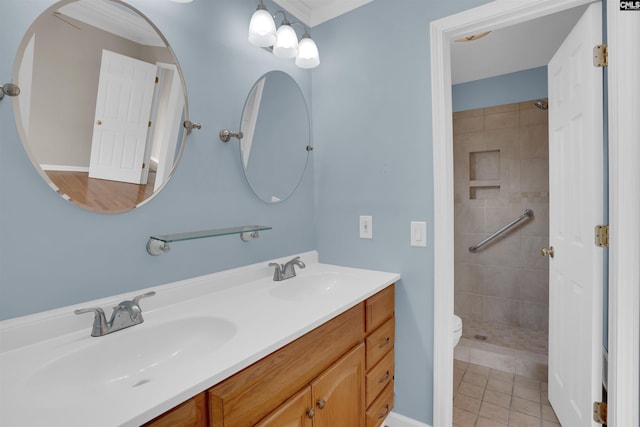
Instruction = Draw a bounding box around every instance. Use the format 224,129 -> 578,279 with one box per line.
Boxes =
12,0 -> 191,215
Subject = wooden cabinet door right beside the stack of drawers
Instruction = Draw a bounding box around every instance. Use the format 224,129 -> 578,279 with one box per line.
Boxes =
311,344 -> 365,427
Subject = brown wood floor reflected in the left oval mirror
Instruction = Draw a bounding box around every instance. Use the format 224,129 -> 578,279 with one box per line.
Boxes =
46,170 -> 156,213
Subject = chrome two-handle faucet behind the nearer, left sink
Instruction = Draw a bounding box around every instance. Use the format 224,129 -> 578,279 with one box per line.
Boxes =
74,291 -> 156,337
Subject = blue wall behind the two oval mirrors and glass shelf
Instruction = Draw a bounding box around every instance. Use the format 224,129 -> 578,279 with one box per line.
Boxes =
0,0 -> 316,319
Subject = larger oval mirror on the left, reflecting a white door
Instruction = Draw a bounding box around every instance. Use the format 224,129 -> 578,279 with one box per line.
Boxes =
13,0 -> 188,213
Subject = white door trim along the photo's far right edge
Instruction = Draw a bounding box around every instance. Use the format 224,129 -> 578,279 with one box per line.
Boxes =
607,1 -> 640,426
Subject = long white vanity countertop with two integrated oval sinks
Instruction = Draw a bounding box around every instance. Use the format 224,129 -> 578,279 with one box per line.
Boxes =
0,251 -> 400,427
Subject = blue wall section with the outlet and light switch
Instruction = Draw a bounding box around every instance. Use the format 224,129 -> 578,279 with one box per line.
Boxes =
312,0 -> 486,424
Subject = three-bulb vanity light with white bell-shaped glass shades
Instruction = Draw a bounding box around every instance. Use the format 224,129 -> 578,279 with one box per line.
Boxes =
249,0 -> 320,68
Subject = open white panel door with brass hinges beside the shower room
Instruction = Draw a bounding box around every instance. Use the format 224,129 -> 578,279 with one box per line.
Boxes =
548,3 -> 603,427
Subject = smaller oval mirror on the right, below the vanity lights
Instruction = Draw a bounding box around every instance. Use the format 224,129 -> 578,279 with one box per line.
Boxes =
240,71 -> 311,203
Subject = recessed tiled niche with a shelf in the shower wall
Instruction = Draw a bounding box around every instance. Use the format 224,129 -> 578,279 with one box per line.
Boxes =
469,150 -> 500,200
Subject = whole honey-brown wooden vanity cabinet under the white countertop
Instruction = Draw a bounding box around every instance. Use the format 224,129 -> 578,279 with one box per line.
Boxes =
145,285 -> 395,427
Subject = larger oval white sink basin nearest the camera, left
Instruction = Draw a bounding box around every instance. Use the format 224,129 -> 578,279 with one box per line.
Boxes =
23,317 -> 237,408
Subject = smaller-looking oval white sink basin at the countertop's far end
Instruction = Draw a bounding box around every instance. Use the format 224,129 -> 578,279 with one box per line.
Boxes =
269,272 -> 356,301
